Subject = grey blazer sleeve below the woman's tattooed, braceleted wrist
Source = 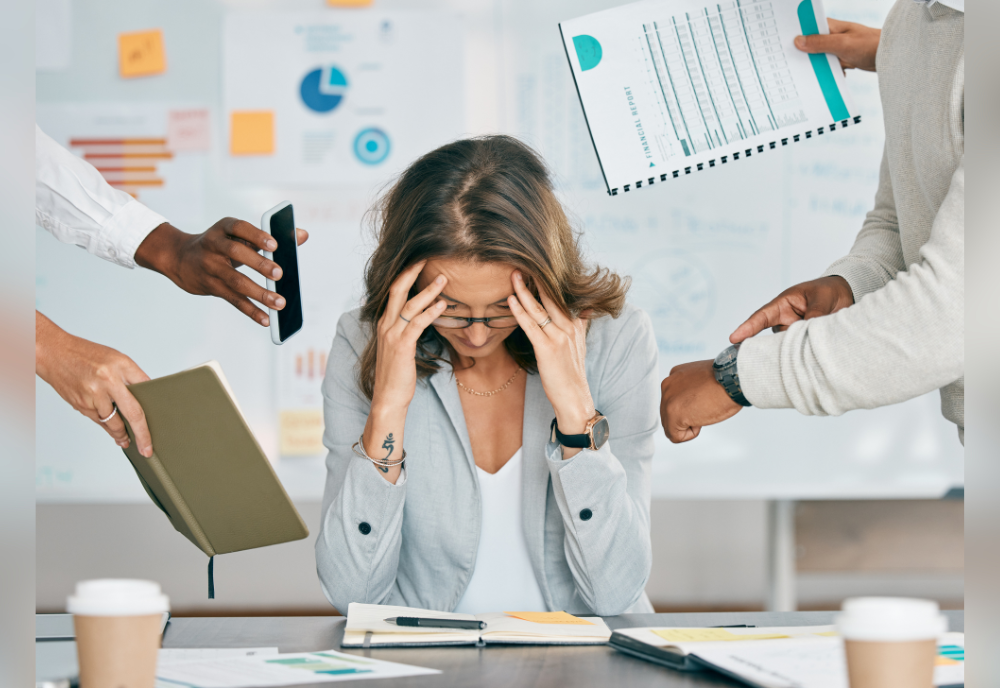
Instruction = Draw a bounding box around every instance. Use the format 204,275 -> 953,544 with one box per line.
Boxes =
316,314 -> 406,615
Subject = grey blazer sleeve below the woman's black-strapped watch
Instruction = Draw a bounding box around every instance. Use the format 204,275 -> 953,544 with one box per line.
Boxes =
546,310 -> 660,616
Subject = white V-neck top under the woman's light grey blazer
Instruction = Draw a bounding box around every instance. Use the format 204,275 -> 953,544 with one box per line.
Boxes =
455,449 -> 548,614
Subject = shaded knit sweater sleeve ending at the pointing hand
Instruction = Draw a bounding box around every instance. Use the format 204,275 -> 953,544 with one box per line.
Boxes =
823,148 -> 906,303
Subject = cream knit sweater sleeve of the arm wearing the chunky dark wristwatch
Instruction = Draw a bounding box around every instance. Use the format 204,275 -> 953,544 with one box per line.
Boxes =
739,160 -> 965,415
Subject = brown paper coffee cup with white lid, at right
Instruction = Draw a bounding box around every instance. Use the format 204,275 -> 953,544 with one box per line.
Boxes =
836,597 -> 948,688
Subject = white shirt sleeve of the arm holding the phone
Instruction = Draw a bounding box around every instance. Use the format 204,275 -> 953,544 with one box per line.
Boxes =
35,125 -> 167,268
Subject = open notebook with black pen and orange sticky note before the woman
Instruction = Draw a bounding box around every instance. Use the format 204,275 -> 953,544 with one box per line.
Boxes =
341,602 -> 611,647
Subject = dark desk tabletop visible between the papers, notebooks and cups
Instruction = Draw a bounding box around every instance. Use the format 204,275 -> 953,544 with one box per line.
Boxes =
163,611 -> 965,688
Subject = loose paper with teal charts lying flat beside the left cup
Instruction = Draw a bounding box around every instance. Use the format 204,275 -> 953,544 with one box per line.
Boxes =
156,650 -> 441,688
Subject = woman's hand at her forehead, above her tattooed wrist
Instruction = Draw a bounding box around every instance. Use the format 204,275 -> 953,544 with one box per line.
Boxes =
372,261 -> 447,414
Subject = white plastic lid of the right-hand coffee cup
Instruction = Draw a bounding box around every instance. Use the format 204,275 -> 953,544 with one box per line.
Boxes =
836,597 -> 948,641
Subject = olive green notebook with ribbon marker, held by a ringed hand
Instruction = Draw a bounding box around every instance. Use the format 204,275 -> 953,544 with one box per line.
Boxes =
124,361 -> 309,597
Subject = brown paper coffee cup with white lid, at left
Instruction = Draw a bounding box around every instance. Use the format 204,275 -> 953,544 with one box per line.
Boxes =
66,579 -> 170,688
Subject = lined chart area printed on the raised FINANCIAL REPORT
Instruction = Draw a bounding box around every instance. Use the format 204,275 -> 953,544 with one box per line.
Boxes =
637,2 -> 806,159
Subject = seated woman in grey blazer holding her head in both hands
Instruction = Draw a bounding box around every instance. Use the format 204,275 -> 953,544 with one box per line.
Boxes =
316,136 -> 659,615
